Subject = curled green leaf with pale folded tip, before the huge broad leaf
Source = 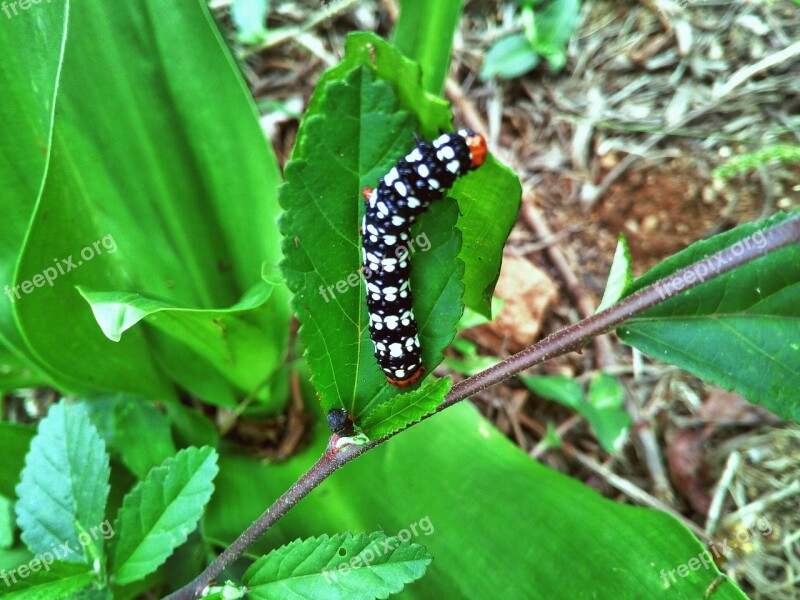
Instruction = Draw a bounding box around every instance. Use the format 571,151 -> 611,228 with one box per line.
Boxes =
78,281 -> 278,404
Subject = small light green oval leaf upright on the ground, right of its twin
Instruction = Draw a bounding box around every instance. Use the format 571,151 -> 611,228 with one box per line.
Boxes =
582,372 -> 631,454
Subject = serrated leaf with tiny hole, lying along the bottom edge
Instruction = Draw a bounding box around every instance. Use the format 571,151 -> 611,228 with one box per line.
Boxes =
243,532 -> 431,600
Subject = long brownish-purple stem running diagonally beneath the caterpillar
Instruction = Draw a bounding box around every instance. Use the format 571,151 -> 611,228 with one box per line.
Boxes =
166,216 -> 800,600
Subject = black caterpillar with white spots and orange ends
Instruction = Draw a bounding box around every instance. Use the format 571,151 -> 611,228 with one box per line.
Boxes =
361,129 -> 487,387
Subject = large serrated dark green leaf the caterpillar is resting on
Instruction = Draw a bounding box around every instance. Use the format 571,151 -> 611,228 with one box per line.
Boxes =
281,67 -> 463,419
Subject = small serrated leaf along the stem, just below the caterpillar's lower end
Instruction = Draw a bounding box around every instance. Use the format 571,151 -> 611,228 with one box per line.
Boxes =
360,377 -> 452,440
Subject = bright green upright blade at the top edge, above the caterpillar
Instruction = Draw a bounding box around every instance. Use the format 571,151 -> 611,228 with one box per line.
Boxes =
394,0 -> 462,96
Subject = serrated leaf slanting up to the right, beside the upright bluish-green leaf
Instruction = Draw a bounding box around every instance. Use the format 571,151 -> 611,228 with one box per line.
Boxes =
111,447 -> 218,585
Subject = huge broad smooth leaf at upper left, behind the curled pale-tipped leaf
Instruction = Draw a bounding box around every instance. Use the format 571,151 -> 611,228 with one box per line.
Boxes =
0,0 -> 289,403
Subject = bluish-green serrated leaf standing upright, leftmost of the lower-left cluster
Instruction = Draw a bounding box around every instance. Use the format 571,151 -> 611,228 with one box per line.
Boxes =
16,400 -> 110,562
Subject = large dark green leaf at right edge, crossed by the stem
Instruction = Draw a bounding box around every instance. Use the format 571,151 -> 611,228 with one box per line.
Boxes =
617,212 -> 800,420
